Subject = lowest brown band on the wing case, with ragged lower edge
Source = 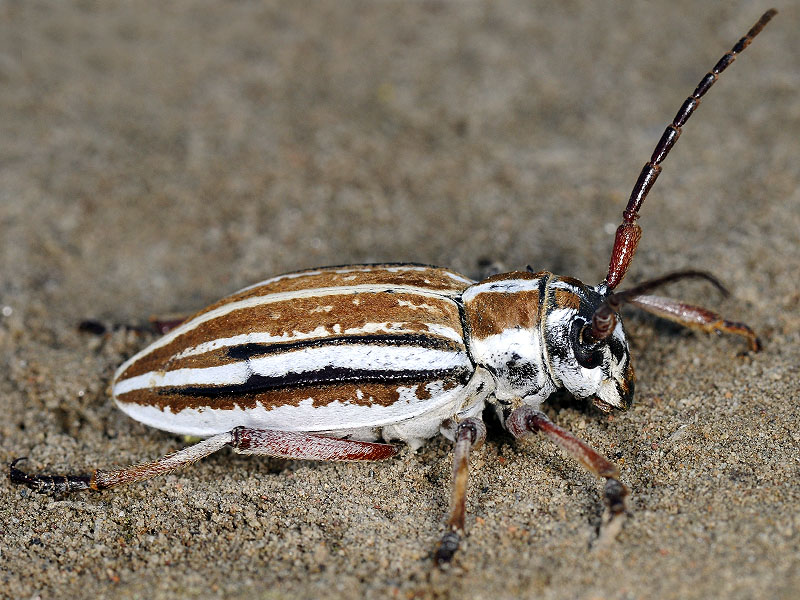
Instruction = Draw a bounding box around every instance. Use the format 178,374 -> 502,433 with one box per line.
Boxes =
117,377 -> 463,413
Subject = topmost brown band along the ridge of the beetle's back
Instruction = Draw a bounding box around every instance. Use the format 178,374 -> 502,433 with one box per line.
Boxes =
199,265 -> 470,314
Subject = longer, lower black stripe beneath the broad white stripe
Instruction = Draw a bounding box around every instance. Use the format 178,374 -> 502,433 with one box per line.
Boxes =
162,366 -> 472,398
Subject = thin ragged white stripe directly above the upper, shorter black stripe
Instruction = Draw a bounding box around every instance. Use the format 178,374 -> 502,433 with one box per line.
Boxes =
174,321 -> 464,360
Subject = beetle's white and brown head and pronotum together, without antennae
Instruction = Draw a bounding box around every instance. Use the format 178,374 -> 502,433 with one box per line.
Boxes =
462,271 -> 634,411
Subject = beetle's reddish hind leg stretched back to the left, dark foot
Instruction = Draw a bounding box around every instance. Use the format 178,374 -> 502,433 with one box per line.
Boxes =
9,427 -> 397,495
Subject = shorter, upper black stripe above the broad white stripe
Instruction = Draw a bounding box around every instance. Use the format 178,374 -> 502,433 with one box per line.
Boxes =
226,333 -> 464,360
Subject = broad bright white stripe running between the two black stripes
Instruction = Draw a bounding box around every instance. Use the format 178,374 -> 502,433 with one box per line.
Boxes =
113,344 -> 472,397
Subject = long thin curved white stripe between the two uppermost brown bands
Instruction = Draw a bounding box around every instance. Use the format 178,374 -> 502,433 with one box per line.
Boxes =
114,284 -> 459,379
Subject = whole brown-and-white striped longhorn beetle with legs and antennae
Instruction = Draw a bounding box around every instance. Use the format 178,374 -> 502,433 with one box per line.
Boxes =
9,10 -> 776,563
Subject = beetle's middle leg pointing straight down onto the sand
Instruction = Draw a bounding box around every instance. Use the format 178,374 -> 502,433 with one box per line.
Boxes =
434,417 -> 486,566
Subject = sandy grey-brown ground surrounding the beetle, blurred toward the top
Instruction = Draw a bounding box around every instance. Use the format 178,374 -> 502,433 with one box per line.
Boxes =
0,0 -> 800,600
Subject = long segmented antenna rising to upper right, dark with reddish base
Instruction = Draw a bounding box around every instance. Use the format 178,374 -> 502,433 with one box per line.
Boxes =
601,8 -> 778,290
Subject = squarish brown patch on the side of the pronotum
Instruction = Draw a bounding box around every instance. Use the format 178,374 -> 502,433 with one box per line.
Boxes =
465,290 -> 539,339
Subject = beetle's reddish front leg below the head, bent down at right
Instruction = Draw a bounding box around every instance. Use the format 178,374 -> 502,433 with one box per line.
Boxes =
506,406 -> 628,545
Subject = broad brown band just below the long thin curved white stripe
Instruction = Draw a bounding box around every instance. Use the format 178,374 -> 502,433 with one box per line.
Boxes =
116,292 -> 461,381
